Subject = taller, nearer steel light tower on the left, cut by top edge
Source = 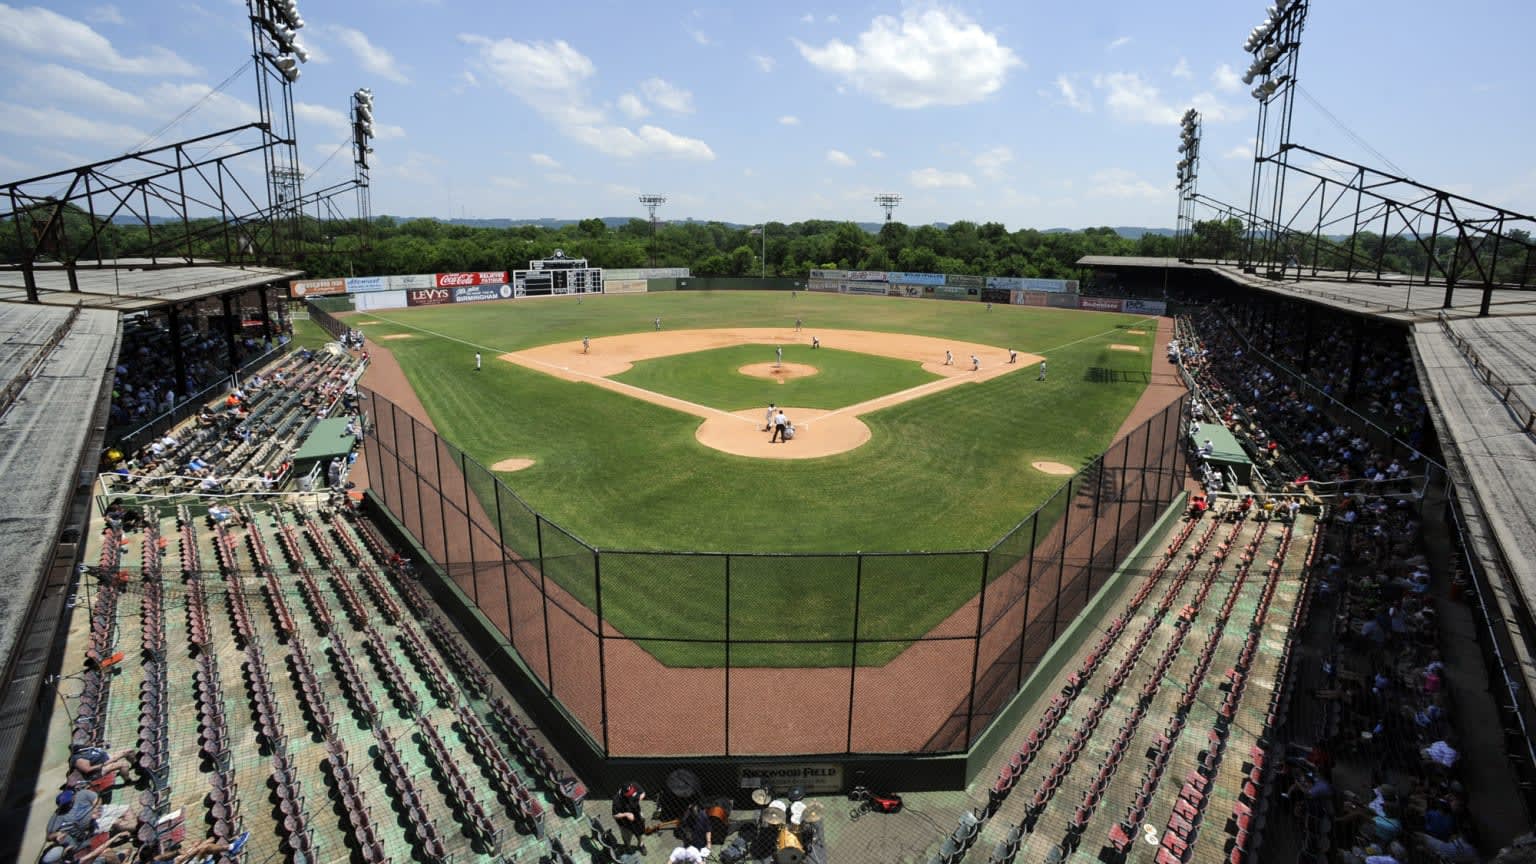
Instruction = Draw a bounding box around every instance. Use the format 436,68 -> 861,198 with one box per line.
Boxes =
246,0 -> 309,255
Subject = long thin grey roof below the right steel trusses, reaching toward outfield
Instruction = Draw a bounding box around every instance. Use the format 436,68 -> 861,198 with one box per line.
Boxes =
1077,255 -> 1536,321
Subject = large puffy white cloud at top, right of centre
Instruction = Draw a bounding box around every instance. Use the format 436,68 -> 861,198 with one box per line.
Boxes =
796,6 -> 1023,108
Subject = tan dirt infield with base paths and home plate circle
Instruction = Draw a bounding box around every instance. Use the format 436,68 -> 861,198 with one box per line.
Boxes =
501,327 -> 1041,460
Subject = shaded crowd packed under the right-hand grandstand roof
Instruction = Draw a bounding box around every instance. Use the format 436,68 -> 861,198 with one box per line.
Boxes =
1169,306 -> 1499,864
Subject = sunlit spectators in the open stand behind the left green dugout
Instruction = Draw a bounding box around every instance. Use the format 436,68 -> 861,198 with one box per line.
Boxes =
111,341 -> 361,493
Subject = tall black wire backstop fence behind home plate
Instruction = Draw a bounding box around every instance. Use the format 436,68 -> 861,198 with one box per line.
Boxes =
361,376 -> 1187,756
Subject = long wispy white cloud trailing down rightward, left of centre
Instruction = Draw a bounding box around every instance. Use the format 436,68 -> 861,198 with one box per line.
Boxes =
459,34 -> 714,160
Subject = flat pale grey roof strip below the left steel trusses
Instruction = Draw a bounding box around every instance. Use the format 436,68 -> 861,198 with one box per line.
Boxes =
0,258 -> 303,312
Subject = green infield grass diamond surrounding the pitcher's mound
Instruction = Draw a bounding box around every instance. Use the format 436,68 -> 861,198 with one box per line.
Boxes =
614,344 -> 938,410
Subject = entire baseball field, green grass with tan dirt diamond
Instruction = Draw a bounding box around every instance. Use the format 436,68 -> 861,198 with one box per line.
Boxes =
349,292 -> 1155,666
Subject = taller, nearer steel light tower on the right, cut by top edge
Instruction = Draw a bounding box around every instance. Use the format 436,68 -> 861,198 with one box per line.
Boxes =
1243,0 -> 1307,272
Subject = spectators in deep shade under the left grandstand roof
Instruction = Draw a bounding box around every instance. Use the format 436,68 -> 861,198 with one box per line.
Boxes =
109,315 -> 289,429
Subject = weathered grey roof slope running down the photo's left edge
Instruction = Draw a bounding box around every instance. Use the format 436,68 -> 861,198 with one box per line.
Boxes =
0,303 -> 118,685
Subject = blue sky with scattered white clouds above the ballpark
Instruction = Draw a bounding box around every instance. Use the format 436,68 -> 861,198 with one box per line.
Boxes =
0,0 -> 1536,229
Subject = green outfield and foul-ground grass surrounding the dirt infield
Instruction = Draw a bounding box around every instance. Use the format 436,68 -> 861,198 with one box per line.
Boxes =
352,292 -> 1155,666
